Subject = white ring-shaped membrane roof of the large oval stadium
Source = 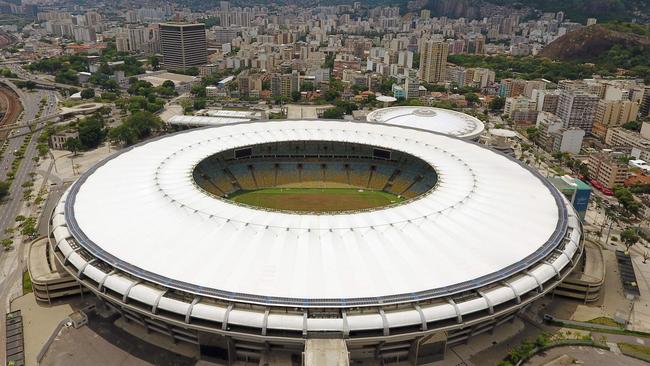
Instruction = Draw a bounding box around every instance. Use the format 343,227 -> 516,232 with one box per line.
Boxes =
63,120 -> 566,303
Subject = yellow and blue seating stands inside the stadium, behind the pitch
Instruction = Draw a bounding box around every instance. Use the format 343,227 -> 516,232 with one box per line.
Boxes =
193,141 -> 437,198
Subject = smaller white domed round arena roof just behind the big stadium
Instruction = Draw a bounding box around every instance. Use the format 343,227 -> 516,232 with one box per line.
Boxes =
366,106 -> 485,140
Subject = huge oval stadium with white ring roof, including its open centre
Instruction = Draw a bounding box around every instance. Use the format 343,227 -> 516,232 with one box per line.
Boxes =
50,117 -> 582,365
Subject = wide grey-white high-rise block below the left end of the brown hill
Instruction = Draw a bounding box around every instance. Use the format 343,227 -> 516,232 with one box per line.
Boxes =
557,90 -> 598,132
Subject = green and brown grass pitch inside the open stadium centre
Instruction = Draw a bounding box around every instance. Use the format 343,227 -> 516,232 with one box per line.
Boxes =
229,188 -> 404,212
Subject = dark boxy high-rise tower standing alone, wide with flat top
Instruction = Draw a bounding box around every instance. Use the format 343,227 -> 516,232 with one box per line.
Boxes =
160,23 -> 208,70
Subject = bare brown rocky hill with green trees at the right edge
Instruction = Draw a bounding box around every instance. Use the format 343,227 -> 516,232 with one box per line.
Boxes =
540,23 -> 650,80
